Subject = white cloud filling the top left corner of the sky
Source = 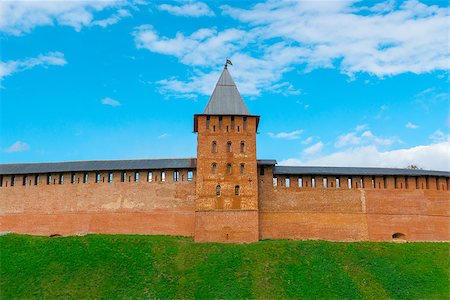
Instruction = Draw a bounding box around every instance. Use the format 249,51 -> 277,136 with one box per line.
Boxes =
0,0 -> 130,35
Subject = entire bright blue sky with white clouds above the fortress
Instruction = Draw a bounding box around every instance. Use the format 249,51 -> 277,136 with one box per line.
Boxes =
0,1 -> 450,170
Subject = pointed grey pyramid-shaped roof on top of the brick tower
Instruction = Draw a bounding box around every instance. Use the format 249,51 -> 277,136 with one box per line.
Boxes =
203,67 -> 250,116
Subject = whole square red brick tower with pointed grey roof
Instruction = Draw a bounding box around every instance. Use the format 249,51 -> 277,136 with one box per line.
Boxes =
194,65 -> 259,242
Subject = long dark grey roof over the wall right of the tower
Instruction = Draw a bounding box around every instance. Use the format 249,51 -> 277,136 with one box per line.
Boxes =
273,166 -> 450,177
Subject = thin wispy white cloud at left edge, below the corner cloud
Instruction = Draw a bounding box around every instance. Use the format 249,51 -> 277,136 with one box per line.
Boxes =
0,52 -> 67,80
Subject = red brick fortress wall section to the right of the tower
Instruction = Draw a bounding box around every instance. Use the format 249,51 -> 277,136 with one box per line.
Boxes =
258,168 -> 450,241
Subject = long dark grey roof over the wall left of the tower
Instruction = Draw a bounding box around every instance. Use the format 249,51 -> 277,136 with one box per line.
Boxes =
0,158 -> 197,175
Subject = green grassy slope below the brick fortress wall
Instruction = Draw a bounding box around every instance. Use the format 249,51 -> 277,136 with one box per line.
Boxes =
0,234 -> 450,299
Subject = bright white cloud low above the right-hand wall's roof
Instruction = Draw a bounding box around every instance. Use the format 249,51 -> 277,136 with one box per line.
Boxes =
280,140 -> 450,171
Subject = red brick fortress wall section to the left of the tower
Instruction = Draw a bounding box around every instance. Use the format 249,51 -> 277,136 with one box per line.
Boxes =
0,170 -> 195,236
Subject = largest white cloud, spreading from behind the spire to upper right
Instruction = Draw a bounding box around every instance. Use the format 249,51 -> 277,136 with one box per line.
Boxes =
138,0 -> 449,98
